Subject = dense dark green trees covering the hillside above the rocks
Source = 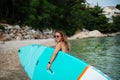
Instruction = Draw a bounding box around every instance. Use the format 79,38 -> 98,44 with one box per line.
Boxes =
0,0 -> 119,36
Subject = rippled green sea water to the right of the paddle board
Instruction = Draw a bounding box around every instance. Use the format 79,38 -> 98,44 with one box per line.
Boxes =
70,36 -> 120,80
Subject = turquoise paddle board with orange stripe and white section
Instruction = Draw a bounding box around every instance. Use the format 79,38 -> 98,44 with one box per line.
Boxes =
18,44 -> 111,80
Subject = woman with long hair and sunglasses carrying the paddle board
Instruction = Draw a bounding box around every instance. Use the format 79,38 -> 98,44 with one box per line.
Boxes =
47,31 -> 69,69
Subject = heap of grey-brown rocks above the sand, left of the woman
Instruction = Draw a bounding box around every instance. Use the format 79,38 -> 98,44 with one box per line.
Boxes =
2,24 -> 52,41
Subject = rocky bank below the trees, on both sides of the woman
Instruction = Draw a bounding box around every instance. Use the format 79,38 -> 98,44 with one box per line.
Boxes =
0,24 -> 120,43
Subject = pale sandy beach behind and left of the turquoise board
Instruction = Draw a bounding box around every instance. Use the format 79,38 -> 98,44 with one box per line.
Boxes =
0,39 -> 55,80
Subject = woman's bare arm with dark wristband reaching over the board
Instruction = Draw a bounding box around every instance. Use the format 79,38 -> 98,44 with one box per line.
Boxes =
47,43 -> 61,69
